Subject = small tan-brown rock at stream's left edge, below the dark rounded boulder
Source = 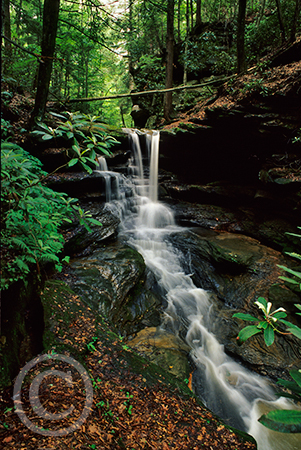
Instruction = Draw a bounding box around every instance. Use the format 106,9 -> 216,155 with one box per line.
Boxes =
127,327 -> 190,380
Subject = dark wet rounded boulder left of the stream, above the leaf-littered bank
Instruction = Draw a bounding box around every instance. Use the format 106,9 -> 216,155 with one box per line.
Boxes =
69,241 -> 162,335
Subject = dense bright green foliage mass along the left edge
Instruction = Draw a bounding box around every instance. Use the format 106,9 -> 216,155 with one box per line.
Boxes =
1,142 -> 101,289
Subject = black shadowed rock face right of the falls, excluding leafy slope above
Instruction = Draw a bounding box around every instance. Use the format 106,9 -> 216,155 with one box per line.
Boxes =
160,90 -> 301,184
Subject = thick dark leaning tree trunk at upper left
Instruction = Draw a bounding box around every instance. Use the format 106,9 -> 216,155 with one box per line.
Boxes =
31,0 -> 60,126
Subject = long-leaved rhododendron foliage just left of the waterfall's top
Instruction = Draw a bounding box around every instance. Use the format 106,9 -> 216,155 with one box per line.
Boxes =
32,112 -> 118,173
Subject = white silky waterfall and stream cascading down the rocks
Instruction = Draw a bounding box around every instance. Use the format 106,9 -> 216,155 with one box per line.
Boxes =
99,131 -> 301,450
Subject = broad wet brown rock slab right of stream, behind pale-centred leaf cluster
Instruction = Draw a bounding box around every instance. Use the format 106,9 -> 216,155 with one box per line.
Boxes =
170,228 -> 301,379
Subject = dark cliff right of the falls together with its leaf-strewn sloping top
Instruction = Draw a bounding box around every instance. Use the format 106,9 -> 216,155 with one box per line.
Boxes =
160,40 -> 301,188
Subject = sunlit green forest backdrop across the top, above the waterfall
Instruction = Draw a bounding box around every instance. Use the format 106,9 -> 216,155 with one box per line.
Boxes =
2,0 -> 301,126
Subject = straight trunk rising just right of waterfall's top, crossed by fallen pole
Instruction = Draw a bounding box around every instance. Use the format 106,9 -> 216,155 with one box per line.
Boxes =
164,0 -> 175,121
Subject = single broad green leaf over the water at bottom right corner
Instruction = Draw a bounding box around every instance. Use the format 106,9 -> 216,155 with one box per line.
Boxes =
258,409 -> 301,433
